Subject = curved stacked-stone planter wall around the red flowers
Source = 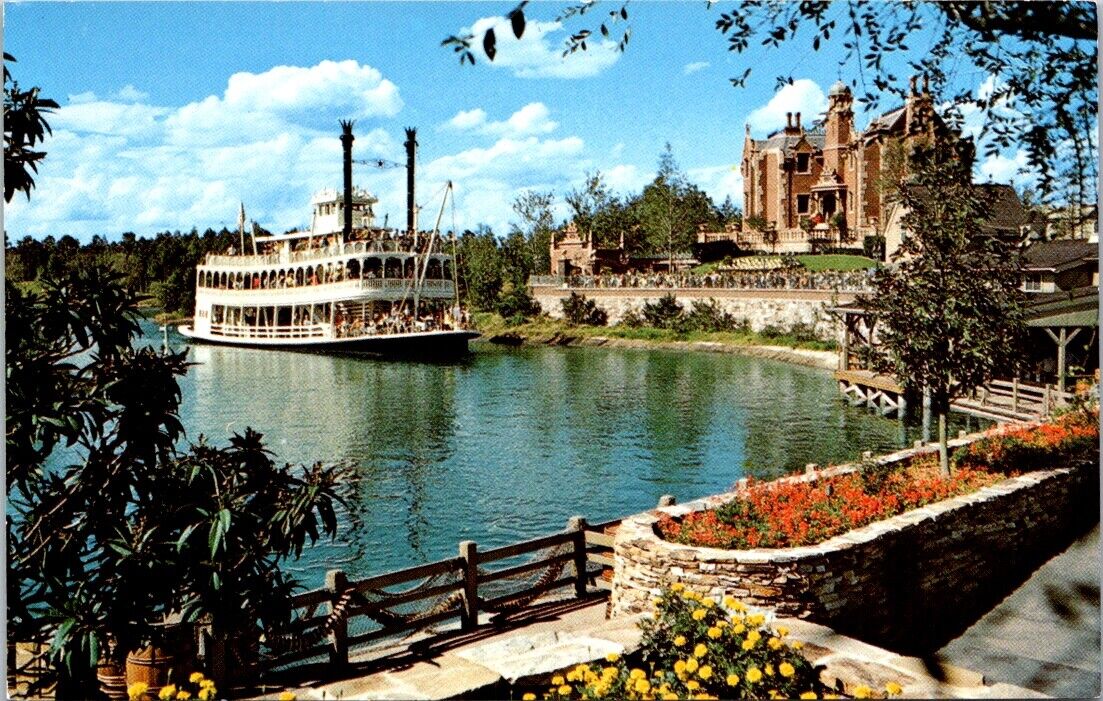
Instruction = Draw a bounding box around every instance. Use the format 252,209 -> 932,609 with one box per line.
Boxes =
611,441 -> 1099,653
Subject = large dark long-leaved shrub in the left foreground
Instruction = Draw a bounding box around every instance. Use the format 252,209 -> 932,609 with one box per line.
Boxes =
6,267 -> 347,698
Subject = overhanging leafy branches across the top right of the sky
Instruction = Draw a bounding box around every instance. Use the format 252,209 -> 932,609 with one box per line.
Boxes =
452,0 -> 1099,212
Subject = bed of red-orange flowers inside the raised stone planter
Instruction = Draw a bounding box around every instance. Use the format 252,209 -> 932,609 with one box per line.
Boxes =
657,410 -> 1099,549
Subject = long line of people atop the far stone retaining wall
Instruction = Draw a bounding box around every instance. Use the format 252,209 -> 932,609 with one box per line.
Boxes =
567,268 -> 874,292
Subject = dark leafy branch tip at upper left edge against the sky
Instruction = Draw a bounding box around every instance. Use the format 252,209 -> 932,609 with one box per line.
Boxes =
3,52 -> 57,202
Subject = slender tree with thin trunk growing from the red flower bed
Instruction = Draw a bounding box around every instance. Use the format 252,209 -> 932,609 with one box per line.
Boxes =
863,145 -> 1022,475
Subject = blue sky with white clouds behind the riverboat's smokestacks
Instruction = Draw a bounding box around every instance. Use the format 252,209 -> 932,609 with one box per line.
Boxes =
3,1 -> 1025,241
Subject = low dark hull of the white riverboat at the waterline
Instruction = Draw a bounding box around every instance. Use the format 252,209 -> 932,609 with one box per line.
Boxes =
176,326 -> 480,358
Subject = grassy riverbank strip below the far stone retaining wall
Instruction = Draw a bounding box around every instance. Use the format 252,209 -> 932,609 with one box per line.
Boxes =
475,314 -> 838,369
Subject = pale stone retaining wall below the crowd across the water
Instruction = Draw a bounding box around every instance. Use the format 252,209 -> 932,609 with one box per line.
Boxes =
533,287 -> 856,341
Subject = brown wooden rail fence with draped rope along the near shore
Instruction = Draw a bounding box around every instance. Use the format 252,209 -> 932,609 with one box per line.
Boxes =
261,509 -> 635,670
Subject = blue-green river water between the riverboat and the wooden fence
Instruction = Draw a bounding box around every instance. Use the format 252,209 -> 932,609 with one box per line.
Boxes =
142,321 -> 983,586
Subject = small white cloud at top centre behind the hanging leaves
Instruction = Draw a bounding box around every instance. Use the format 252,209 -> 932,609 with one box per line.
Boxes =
462,17 -> 621,78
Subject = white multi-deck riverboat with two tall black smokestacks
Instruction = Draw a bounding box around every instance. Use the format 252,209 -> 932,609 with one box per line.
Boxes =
178,122 -> 479,357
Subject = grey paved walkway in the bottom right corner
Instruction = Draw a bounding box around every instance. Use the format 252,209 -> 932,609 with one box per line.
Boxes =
935,526 -> 1101,699
